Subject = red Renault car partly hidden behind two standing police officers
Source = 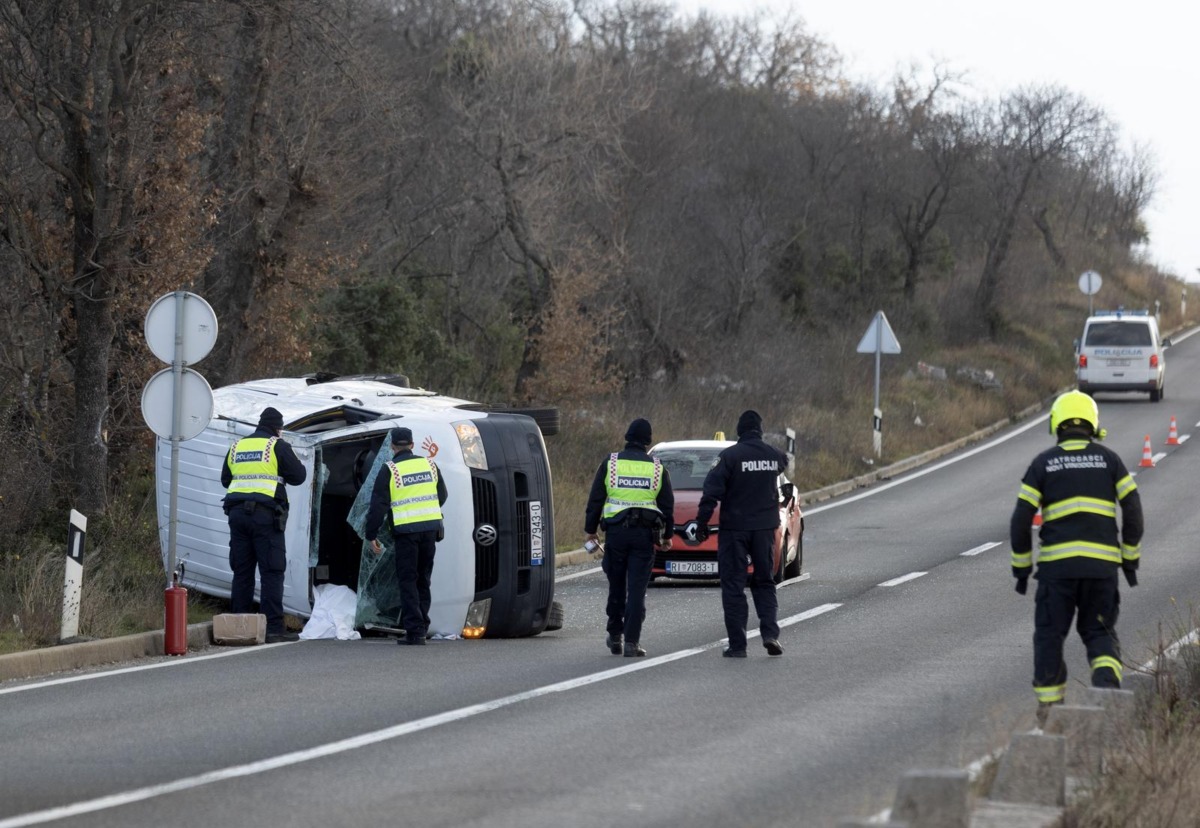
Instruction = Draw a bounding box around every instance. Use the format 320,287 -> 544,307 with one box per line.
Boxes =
650,434 -> 804,583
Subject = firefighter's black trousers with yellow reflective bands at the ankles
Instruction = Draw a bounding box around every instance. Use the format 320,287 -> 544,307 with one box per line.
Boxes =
1033,574 -> 1121,701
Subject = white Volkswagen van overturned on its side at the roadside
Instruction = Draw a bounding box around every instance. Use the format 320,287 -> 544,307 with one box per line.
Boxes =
156,376 -> 562,637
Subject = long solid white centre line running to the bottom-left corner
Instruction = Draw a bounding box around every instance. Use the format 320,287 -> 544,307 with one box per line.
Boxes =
0,604 -> 841,828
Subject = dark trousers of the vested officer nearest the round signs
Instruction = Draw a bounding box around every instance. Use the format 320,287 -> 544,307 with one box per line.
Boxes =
229,503 -> 288,635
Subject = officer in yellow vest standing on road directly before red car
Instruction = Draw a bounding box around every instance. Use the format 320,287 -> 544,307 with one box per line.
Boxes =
583,418 -> 674,658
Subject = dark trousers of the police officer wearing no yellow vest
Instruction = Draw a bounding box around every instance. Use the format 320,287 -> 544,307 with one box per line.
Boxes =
716,528 -> 779,650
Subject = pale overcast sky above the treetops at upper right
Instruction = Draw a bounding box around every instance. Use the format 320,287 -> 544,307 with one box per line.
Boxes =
674,0 -> 1200,281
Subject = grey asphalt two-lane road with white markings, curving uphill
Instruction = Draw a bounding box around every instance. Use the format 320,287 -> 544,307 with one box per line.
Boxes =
0,326 -> 1200,828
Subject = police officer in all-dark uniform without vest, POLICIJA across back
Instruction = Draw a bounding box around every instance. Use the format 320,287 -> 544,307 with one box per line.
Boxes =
694,410 -> 787,659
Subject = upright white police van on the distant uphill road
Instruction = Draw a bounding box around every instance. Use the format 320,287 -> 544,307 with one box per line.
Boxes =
1075,308 -> 1171,402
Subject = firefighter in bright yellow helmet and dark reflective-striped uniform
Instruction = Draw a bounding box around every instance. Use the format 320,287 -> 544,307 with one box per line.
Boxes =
1009,391 -> 1142,724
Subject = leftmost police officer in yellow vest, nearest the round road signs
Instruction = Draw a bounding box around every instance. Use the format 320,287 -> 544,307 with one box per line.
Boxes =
221,408 -> 307,644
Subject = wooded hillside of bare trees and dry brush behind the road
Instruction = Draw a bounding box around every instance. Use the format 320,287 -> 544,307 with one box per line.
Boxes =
0,0 -> 1182,644
